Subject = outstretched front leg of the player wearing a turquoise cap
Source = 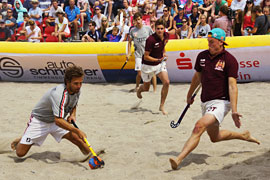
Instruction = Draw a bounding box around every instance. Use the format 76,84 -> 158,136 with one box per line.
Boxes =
170,114 -> 216,170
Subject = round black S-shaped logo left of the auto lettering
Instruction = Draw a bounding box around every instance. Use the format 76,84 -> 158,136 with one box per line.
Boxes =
0,57 -> 23,78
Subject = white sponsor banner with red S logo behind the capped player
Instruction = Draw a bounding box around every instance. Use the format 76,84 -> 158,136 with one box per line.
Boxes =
167,46 -> 270,82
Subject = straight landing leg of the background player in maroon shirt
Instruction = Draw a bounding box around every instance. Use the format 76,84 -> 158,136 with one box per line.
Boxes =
158,71 -> 170,115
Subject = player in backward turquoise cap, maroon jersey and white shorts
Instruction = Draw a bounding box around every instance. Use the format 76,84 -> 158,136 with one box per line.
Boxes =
170,28 -> 260,170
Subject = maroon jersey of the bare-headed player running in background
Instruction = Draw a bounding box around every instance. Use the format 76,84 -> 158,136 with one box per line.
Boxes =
142,32 -> 169,66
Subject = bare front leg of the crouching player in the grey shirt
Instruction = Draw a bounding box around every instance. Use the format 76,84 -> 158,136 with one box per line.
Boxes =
63,132 -> 90,155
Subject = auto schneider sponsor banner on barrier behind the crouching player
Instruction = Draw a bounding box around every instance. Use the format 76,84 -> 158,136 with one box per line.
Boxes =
0,53 -> 106,83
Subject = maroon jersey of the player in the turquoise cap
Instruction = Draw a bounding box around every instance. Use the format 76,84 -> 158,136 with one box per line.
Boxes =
195,50 -> 238,102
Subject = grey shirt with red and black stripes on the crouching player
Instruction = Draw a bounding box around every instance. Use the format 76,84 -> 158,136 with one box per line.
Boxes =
32,84 -> 80,123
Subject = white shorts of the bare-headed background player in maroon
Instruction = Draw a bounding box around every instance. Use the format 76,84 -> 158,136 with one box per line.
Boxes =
141,62 -> 167,82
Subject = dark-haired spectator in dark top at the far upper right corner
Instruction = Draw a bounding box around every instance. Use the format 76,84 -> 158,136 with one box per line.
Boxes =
248,6 -> 270,35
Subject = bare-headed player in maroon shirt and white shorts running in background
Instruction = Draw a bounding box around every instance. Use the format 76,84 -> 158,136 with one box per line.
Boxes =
137,18 -> 170,115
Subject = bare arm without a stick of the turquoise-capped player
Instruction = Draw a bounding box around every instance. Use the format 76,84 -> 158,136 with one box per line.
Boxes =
229,77 -> 242,128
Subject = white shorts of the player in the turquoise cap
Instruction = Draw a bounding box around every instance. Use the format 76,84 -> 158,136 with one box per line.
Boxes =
201,100 -> 231,124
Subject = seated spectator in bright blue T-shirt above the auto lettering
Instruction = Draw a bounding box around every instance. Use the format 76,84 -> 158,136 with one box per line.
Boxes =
65,0 -> 81,40
